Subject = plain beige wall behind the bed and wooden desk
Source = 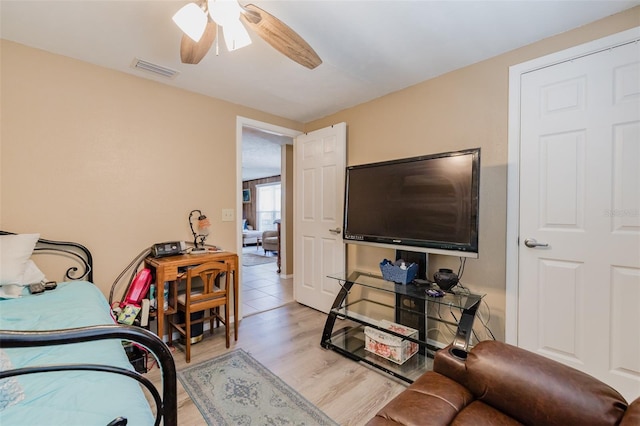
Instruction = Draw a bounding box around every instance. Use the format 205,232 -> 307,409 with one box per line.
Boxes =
0,40 -> 302,293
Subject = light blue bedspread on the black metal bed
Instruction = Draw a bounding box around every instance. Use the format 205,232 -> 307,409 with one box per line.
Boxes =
0,282 -> 154,426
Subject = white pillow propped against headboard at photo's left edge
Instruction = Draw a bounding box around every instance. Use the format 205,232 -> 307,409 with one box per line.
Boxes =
0,234 -> 40,285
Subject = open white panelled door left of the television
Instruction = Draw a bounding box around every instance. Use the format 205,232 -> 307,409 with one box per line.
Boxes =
293,123 -> 347,312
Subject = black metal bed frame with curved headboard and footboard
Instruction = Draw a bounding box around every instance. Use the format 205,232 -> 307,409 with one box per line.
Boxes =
0,231 -> 178,426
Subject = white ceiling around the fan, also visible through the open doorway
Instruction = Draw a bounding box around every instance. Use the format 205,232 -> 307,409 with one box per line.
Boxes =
0,0 -> 640,179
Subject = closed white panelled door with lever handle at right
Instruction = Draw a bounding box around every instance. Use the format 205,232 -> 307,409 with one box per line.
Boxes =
517,39 -> 640,400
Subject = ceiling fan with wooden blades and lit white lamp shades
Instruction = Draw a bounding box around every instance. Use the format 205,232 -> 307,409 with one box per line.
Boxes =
173,0 -> 322,69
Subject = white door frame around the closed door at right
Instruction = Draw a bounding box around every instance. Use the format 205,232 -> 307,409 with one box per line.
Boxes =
505,27 -> 640,346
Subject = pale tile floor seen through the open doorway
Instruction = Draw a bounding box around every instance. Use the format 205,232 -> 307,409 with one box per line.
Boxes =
240,246 -> 293,317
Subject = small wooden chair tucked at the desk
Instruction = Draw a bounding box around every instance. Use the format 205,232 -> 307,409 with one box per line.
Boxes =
169,262 -> 232,362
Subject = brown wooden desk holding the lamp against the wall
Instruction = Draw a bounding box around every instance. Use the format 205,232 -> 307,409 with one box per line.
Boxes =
144,251 -> 238,340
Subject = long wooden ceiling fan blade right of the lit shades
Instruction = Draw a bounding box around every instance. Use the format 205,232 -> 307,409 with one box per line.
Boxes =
240,4 -> 322,69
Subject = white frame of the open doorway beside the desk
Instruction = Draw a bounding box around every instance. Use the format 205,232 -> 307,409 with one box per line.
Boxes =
236,116 -> 303,320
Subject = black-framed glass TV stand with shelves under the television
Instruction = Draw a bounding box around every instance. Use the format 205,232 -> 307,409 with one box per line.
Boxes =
320,271 -> 483,383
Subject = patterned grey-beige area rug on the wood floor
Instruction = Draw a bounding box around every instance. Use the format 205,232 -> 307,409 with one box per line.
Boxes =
178,349 -> 337,426
